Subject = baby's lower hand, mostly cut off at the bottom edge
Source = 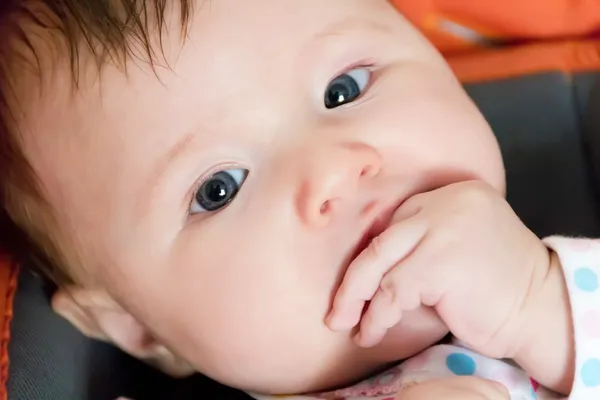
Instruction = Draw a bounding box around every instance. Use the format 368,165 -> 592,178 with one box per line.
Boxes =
396,377 -> 510,400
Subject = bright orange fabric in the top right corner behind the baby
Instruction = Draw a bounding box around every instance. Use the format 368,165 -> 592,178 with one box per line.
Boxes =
391,0 -> 600,83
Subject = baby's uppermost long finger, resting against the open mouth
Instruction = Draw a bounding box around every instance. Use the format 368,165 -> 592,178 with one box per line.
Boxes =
328,215 -> 427,330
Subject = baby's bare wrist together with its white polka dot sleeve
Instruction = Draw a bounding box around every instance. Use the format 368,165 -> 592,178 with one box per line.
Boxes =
515,238 -> 600,400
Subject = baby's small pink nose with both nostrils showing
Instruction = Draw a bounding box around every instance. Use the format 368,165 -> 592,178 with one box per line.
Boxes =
297,143 -> 382,226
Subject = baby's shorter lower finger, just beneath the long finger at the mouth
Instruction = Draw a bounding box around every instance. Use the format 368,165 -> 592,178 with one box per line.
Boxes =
355,270 -> 421,347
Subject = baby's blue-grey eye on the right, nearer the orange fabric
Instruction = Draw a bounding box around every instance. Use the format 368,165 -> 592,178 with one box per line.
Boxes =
325,68 -> 371,109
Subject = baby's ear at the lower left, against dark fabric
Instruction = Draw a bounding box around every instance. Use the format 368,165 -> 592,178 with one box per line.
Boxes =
52,287 -> 194,377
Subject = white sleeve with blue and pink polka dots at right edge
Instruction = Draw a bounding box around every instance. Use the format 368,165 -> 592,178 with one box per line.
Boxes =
544,237 -> 600,400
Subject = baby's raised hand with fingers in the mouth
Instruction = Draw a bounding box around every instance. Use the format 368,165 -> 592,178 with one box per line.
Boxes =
328,182 -> 549,358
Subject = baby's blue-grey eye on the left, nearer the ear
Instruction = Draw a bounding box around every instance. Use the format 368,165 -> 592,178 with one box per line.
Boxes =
190,169 -> 249,214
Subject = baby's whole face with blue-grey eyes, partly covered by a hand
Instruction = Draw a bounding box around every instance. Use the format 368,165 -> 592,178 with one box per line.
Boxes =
18,0 -> 503,391
